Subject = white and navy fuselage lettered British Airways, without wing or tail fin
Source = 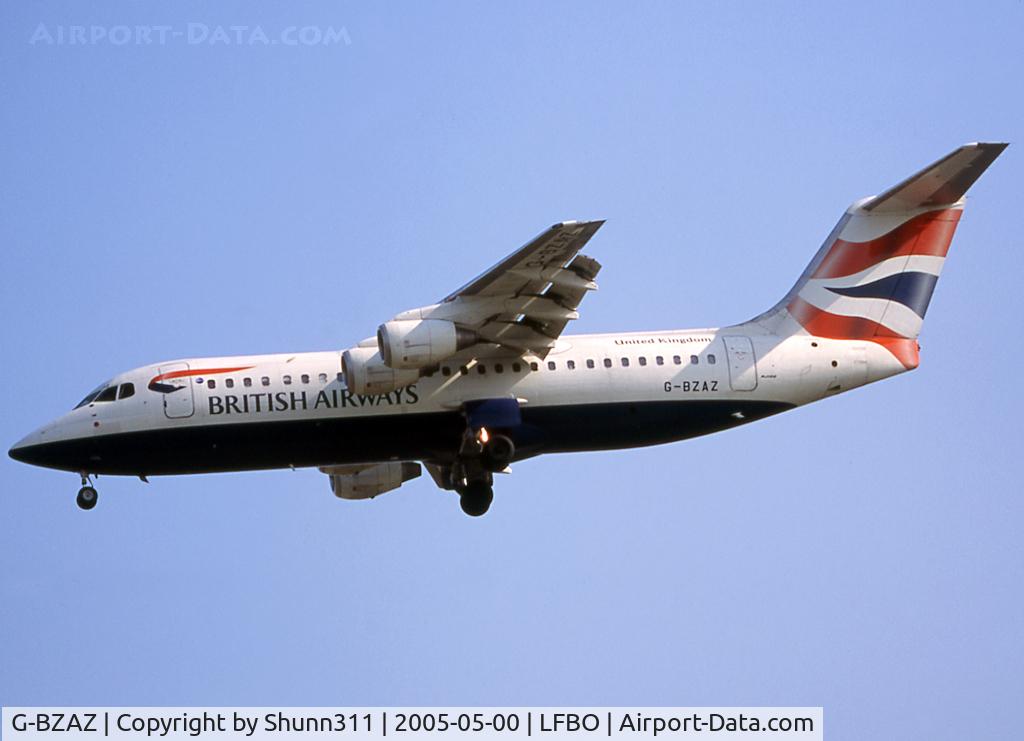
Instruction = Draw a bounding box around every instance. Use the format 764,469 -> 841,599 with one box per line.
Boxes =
6,324 -> 905,475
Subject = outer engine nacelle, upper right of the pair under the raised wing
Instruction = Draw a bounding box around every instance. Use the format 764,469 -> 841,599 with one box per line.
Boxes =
377,319 -> 477,368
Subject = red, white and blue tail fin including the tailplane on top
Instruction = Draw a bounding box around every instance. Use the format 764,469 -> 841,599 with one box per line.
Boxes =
754,142 -> 1007,368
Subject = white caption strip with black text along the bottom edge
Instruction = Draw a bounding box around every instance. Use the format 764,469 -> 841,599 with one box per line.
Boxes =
0,707 -> 823,741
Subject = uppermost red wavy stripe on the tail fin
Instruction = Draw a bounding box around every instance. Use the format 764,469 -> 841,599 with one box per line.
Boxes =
811,209 -> 963,278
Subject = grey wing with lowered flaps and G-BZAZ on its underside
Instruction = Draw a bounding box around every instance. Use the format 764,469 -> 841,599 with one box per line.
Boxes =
435,221 -> 604,357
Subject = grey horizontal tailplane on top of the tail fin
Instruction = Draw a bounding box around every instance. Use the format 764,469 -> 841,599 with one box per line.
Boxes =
861,142 -> 1009,213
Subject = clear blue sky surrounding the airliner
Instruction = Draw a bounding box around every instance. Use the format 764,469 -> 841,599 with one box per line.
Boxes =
0,2 -> 1024,741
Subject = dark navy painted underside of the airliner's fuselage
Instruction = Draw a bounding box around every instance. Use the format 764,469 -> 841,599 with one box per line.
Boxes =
18,398 -> 793,476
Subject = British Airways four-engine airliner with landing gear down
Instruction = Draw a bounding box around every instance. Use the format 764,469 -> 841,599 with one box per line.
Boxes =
9,142 -> 1007,517
